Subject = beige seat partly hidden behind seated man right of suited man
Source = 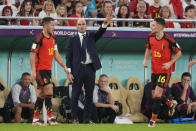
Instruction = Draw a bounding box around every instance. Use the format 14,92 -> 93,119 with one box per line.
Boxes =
109,77 -> 129,115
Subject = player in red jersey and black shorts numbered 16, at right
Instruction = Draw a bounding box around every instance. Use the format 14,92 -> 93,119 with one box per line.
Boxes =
143,18 -> 182,127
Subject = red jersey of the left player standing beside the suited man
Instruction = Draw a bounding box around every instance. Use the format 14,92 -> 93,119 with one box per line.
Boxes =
31,33 -> 57,70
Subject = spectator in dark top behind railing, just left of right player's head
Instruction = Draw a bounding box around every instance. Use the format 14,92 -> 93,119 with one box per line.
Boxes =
132,2 -> 150,28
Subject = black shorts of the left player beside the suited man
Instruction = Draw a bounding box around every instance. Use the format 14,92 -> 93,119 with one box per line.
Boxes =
36,70 -> 51,89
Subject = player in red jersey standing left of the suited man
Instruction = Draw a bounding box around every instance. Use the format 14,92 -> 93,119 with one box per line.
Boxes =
30,17 -> 71,125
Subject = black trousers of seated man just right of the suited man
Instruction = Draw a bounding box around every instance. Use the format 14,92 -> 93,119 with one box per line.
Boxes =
95,107 -> 117,123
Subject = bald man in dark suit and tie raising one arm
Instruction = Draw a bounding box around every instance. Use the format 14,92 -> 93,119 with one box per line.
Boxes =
66,16 -> 111,123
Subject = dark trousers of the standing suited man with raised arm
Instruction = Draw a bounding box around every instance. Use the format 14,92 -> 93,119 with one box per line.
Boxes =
71,64 -> 95,121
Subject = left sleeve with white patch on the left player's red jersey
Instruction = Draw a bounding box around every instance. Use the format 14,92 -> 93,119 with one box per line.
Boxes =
31,34 -> 43,53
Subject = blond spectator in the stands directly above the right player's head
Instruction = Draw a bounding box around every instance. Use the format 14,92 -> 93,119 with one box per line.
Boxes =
159,5 -> 175,28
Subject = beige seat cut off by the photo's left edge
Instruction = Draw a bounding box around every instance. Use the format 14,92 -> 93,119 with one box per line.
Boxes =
0,77 -> 10,122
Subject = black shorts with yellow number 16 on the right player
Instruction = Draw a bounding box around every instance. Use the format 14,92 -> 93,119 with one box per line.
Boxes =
151,73 -> 171,90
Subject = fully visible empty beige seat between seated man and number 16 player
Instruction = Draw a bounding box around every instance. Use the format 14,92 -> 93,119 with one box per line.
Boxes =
126,77 -> 148,122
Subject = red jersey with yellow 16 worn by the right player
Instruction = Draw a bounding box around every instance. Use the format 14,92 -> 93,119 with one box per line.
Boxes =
146,33 -> 181,74
